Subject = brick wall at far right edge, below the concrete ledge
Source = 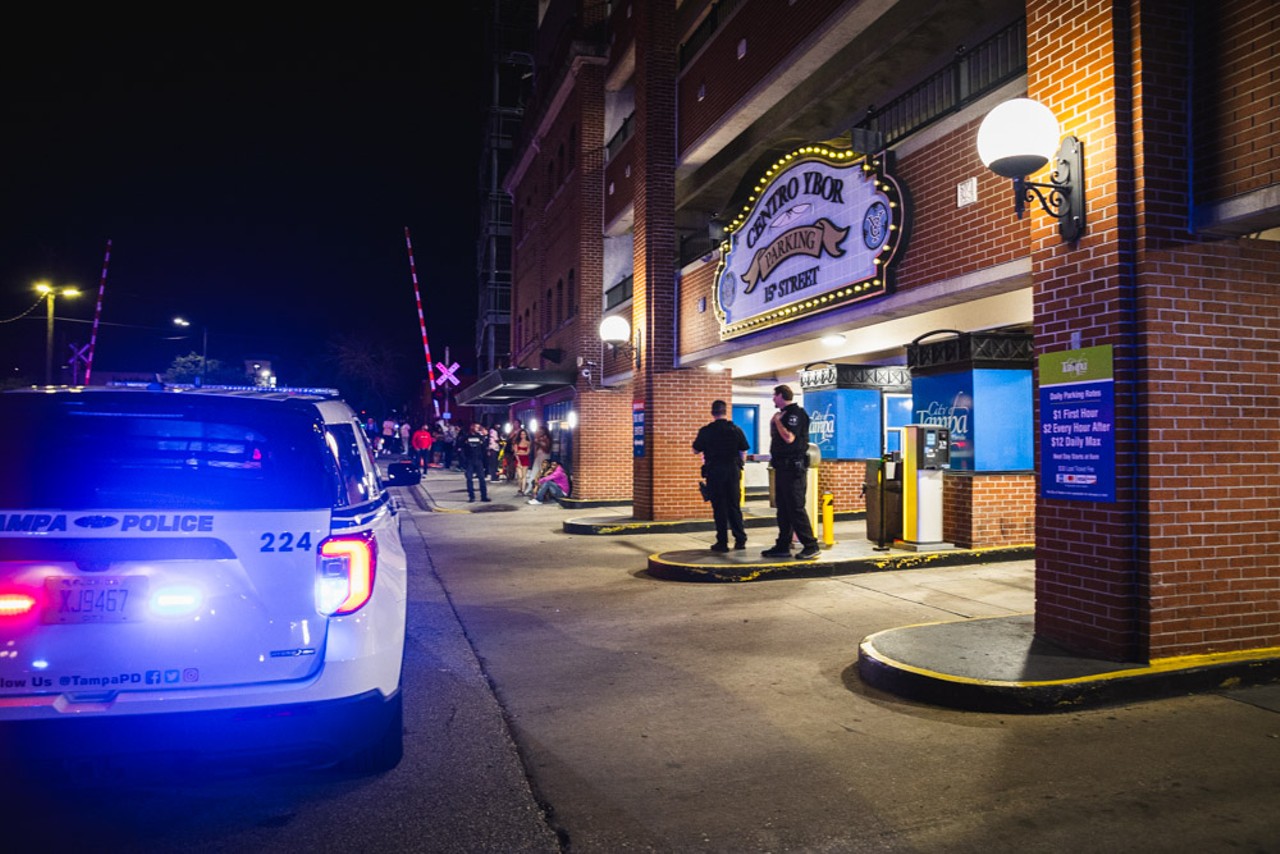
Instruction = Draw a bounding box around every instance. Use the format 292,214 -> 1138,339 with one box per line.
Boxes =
1142,241 -> 1280,658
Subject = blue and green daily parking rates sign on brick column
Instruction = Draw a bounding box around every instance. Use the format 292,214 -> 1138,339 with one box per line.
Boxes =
1039,344 -> 1116,502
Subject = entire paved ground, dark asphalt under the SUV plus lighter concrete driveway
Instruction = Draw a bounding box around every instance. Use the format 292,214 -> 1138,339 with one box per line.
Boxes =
0,471 -> 1280,854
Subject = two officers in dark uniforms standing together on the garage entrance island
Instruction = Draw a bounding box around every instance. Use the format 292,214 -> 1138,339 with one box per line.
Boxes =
694,385 -> 820,561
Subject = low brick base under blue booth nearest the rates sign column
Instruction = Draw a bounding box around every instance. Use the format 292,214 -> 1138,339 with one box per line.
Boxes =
942,471 -> 1036,548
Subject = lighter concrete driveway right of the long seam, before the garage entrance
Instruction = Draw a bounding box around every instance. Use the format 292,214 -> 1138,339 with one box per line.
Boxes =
404,471 -> 1280,853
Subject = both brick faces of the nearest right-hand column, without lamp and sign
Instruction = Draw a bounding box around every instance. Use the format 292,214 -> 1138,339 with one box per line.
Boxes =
1028,0 -> 1280,661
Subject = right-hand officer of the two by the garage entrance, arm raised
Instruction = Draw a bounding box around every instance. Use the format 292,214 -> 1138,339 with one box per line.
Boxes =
760,385 -> 819,561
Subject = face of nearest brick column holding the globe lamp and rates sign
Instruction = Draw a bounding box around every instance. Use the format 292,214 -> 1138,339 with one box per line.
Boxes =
1027,0 -> 1146,661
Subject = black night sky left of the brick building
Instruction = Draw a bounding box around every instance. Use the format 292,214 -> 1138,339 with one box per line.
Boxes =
0,10 -> 488,404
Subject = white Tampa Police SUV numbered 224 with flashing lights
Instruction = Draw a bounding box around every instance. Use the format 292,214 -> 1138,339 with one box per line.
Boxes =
0,388 -> 416,771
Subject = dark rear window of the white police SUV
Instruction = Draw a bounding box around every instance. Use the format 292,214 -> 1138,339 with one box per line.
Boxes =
0,393 -> 338,510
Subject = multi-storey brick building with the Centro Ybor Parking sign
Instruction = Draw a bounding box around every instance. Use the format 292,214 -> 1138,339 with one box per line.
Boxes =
460,0 -> 1280,661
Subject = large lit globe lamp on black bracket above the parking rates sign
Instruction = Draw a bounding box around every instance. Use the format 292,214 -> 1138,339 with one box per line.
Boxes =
978,97 -> 1084,242
